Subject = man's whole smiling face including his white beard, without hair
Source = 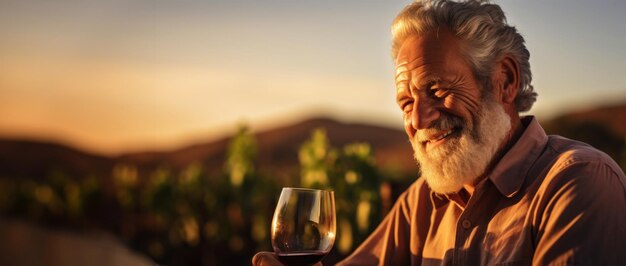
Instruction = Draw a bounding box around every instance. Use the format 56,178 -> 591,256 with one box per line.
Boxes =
396,30 -> 511,193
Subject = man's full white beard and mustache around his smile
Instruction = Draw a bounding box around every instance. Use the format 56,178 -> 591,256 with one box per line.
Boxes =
411,99 -> 511,194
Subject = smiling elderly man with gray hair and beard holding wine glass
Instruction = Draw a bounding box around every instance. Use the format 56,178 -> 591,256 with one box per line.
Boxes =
253,1 -> 626,265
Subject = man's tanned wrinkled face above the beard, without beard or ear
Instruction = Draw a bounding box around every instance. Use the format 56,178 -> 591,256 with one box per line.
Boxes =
396,30 -> 481,143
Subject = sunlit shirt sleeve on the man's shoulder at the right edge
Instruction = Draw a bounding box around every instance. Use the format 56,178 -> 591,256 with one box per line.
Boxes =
533,161 -> 626,265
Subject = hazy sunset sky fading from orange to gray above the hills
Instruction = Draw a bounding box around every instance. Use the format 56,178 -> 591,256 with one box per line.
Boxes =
0,0 -> 626,154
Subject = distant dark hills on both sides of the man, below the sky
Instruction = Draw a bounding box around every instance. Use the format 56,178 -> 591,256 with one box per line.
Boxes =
0,103 -> 626,182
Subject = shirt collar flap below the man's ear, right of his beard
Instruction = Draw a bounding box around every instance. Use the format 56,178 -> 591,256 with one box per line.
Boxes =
488,116 -> 548,198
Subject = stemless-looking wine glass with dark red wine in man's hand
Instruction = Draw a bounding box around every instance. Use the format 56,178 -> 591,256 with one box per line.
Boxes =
272,188 -> 336,265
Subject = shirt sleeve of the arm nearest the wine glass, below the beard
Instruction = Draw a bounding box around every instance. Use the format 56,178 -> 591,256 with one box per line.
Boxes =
338,179 -> 424,266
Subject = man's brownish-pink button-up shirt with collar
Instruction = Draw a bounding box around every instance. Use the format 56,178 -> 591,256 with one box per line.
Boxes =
340,117 -> 626,265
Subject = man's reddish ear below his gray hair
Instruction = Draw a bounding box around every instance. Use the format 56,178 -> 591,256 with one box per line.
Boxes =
492,55 -> 520,104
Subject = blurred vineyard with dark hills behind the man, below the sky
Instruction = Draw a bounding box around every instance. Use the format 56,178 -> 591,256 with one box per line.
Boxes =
0,102 -> 626,265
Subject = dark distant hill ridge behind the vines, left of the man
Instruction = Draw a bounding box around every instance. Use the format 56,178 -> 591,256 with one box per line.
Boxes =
0,117 -> 417,181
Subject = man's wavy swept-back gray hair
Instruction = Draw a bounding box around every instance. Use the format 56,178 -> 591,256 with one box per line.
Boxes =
391,0 -> 537,112
